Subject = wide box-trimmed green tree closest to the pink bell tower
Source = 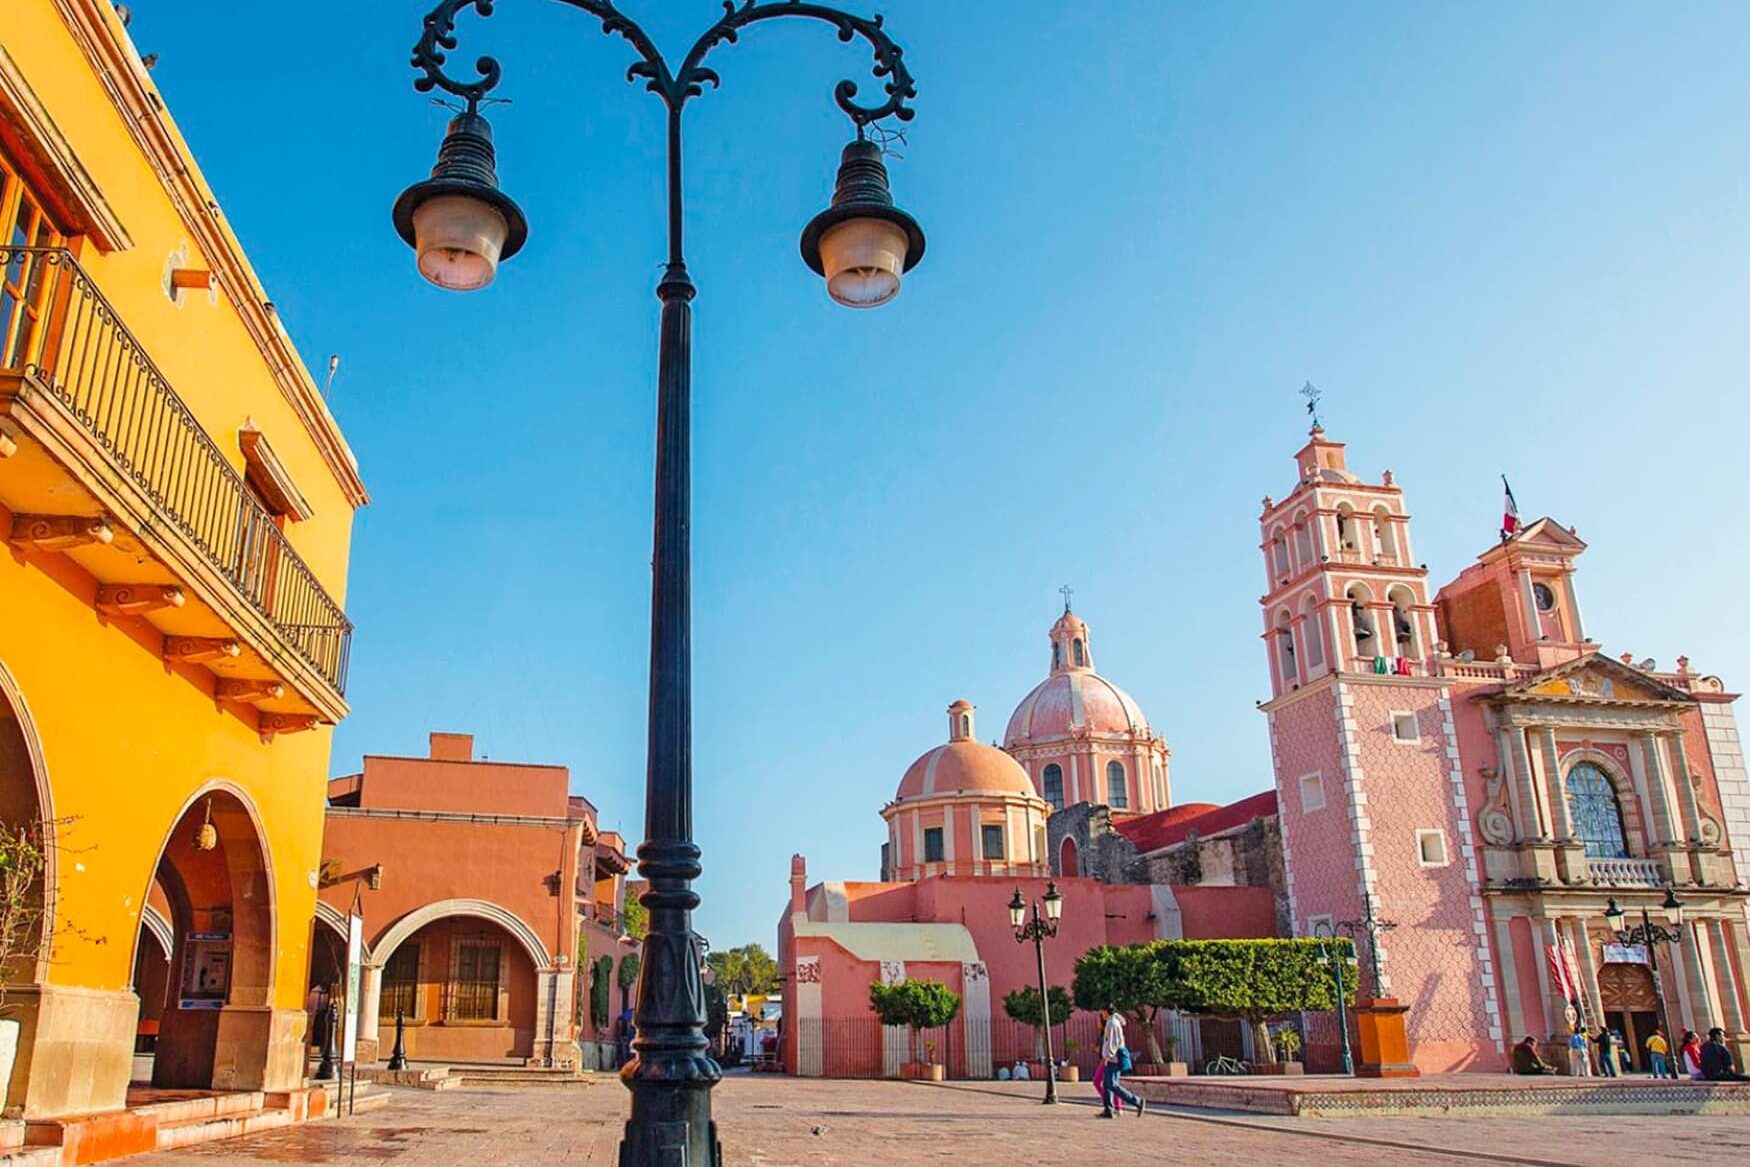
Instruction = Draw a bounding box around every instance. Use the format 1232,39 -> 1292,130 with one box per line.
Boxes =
1155,940 -> 1355,1062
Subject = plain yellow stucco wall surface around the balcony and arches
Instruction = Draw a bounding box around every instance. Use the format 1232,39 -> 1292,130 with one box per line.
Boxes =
0,0 -> 362,1097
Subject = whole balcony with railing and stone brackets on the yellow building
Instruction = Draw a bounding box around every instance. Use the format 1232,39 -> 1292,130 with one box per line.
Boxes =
0,248 -> 352,738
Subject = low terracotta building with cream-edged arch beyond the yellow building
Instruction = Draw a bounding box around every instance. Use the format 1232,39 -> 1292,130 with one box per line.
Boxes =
312,733 -> 635,1066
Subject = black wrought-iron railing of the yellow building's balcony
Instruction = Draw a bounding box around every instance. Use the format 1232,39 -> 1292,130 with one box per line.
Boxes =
0,247 -> 352,695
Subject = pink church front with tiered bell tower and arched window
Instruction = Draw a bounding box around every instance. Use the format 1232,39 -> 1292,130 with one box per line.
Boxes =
1260,429 -> 1750,1071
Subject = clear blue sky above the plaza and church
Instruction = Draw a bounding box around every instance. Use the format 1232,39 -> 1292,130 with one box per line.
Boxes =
143,0 -> 1750,947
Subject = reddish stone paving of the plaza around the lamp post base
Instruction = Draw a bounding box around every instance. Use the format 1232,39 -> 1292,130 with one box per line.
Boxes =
135,1076 -> 1750,1167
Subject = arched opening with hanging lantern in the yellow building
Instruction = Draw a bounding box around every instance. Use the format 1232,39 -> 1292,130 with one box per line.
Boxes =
135,784 -> 275,1090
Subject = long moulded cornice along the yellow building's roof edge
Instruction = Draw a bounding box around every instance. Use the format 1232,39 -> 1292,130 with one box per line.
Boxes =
54,0 -> 371,507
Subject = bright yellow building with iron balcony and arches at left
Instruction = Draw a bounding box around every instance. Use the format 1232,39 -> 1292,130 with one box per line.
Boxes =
0,0 -> 366,1116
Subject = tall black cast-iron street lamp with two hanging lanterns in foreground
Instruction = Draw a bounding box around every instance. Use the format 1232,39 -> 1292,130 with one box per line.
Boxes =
394,0 -> 924,1167
